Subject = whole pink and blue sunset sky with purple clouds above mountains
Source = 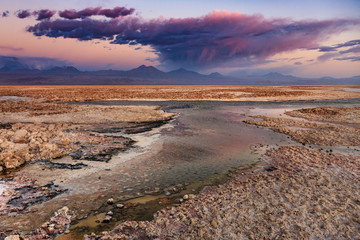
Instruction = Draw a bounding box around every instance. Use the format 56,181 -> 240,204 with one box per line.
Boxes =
0,0 -> 360,77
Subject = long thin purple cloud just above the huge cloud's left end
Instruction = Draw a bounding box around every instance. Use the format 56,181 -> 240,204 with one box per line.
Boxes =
59,7 -> 135,20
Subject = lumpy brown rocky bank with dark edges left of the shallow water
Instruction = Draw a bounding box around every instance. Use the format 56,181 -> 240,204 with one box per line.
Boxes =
0,101 -> 173,171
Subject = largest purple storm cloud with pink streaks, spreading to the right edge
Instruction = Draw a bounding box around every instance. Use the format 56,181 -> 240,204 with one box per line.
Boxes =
28,11 -> 360,68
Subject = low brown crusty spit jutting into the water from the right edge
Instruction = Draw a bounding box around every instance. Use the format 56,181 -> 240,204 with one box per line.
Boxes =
245,107 -> 360,146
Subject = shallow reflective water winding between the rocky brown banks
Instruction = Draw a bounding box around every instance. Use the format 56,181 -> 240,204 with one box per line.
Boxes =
0,101 -> 360,239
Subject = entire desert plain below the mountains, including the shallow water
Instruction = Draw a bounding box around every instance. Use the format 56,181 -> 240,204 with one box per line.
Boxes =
0,86 -> 360,240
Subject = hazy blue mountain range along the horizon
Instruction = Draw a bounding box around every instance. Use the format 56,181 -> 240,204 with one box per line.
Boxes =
0,58 -> 360,85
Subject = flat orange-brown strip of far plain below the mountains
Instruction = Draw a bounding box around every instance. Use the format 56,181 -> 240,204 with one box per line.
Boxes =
0,86 -> 360,102
